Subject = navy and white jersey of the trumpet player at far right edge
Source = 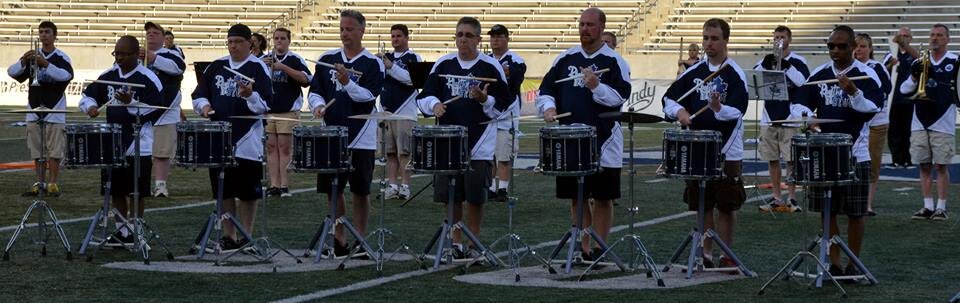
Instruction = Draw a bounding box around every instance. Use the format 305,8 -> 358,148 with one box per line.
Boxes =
900,51 -> 960,135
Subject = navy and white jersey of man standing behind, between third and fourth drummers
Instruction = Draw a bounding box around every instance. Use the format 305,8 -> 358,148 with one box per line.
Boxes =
380,49 -> 423,117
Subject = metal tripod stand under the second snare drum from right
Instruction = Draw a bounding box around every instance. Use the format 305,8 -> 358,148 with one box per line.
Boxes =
663,178 -> 756,279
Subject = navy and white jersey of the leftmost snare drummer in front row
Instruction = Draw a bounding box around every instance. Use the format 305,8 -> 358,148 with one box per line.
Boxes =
79,64 -> 163,156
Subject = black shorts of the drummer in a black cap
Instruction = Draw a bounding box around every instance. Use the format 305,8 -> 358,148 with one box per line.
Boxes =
210,158 -> 263,201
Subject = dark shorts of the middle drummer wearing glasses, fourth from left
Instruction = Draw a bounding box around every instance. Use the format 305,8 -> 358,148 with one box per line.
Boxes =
433,160 -> 493,205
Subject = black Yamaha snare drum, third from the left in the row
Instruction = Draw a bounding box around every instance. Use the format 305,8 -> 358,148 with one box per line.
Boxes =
293,125 -> 350,173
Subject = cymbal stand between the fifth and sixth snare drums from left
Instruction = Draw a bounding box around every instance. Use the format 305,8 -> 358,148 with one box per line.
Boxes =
580,120 -> 666,287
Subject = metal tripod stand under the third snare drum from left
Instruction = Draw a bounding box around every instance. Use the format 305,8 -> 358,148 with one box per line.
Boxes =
303,173 -> 381,269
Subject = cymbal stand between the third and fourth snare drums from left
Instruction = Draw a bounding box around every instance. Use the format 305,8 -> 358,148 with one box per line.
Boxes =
339,121 -> 424,275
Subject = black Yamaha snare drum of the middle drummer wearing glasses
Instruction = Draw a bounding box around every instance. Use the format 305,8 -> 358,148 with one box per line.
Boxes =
410,125 -> 470,174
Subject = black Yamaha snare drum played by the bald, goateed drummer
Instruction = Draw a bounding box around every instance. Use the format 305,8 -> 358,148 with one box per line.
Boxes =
539,124 -> 600,176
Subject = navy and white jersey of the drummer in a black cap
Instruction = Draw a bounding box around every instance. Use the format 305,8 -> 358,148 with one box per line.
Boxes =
192,55 -> 273,161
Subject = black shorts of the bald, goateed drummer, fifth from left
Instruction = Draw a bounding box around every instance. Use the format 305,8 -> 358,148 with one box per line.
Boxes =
556,167 -> 620,200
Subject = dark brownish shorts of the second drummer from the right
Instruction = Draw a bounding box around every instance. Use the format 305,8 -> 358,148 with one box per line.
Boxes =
683,161 -> 747,212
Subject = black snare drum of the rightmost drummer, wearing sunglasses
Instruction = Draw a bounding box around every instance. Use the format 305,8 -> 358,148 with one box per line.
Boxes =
790,133 -> 855,186
